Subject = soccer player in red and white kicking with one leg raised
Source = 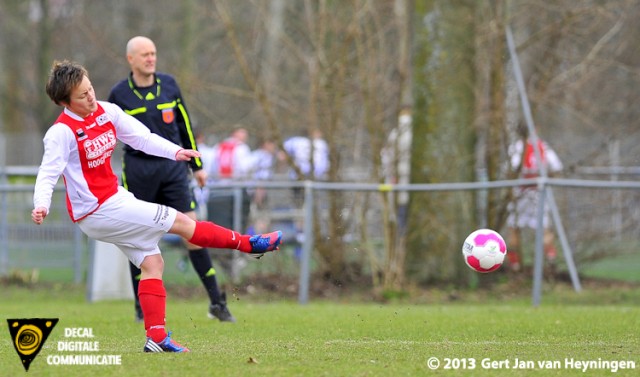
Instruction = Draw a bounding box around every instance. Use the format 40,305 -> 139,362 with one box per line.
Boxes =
31,60 -> 282,352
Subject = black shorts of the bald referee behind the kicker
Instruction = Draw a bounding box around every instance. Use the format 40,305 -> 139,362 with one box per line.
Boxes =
122,153 -> 195,212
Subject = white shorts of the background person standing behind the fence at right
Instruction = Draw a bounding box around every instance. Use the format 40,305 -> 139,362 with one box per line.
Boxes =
507,188 -> 549,229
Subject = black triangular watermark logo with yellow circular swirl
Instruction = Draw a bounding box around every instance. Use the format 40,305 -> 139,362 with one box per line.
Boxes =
7,318 -> 58,371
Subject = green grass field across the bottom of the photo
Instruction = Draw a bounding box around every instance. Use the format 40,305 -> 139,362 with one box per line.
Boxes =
0,285 -> 640,377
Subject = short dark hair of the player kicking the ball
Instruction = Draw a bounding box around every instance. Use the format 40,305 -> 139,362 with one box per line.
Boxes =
45,60 -> 89,105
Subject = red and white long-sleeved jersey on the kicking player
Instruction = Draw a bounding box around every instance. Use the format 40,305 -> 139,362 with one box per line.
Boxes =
33,101 -> 181,222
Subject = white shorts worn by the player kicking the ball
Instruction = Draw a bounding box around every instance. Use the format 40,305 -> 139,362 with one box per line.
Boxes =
78,187 -> 177,267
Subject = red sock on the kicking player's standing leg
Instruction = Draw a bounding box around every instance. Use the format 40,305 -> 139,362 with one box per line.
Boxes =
138,279 -> 167,343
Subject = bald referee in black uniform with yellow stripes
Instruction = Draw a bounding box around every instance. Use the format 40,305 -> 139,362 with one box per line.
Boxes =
108,36 -> 236,322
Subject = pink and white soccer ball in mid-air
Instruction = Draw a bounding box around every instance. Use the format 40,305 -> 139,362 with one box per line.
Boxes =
462,229 -> 507,273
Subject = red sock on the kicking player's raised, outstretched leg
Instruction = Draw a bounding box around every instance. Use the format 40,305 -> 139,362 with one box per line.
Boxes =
189,221 -> 251,253
